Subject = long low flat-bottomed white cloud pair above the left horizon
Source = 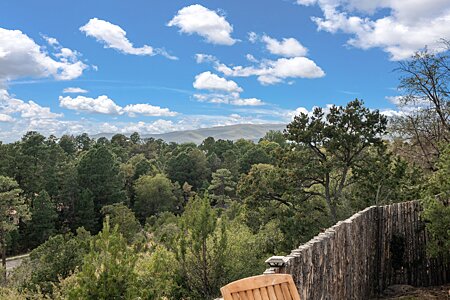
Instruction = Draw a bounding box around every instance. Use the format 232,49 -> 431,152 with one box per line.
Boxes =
59,95 -> 177,117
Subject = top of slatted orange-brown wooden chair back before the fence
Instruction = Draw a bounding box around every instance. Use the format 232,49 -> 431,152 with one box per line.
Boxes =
220,274 -> 300,300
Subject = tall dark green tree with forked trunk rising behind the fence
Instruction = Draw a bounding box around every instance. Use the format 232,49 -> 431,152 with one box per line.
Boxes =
283,99 -> 387,222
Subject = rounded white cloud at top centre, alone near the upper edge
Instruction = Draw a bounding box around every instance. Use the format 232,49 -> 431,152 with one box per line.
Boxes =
167,4 -> 236,46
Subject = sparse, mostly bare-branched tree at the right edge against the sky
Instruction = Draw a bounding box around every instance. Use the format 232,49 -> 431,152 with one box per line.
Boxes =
392,40 -> 450,171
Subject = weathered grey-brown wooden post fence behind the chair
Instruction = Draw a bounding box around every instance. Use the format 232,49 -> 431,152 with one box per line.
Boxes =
266,201 -> 450,300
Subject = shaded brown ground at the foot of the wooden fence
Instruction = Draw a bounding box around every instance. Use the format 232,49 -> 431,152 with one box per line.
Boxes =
377,284 -> 450,300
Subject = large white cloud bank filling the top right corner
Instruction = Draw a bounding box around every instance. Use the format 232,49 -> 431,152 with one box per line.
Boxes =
297,0 -> 450,60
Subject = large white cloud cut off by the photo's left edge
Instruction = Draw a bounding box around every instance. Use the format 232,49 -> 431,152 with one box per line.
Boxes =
0,28 -> 87,81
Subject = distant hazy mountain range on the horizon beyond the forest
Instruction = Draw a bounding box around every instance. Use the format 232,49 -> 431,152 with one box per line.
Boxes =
92,124 -> 286,144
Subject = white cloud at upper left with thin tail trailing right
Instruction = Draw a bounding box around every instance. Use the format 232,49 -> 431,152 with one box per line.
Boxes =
80,18 -> 177,59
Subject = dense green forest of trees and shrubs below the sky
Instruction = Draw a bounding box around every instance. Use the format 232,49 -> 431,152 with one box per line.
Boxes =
0,45 -> 450,299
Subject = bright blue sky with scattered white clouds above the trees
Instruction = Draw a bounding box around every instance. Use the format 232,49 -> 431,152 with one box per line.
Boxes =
0,0 -> 450,142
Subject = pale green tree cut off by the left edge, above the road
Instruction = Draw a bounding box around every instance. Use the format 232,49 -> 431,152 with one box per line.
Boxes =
0,176 -> 29,275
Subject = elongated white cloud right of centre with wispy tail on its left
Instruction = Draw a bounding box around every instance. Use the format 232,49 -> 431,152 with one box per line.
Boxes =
196,54 -> 325,85
